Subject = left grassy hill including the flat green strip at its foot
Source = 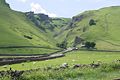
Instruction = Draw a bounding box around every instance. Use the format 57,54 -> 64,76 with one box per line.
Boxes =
0,0 -> 62,54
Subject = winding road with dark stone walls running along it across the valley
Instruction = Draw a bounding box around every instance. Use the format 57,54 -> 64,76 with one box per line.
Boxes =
0,48 -> 120,66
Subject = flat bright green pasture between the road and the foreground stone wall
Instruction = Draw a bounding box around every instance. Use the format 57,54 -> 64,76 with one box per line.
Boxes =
0,51 -> 120,70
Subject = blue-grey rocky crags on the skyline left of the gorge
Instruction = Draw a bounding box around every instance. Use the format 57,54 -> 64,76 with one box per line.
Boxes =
26,12 -> 70,32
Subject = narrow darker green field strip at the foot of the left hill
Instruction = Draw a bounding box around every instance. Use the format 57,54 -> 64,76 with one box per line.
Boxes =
0,48 -> 58,54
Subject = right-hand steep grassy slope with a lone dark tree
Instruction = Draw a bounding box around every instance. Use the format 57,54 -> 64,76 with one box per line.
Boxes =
56,6 -> 120,50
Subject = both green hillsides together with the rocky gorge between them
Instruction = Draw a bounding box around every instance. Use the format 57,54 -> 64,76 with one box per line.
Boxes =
0,0 -> 120,50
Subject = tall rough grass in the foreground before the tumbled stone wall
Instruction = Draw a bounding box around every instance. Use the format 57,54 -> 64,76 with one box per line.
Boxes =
0,62 -> 120,80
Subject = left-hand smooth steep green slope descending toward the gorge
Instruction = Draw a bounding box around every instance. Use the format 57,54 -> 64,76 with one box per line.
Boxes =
0,0 -> 54,47
